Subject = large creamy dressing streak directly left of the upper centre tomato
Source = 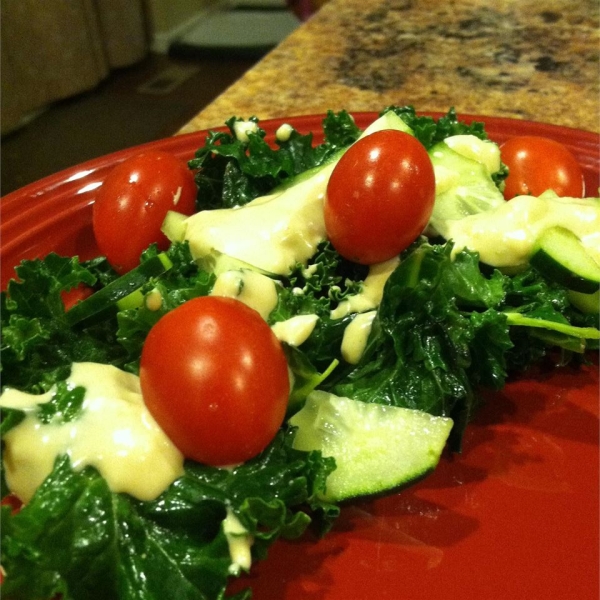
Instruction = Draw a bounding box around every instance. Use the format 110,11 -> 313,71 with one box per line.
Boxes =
184,161 -> 337,275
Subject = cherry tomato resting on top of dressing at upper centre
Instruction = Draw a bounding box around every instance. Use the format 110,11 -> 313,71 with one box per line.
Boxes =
324,130 -> 435,264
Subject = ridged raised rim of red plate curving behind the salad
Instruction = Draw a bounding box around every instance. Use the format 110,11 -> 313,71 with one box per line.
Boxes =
0,110 -> 600,289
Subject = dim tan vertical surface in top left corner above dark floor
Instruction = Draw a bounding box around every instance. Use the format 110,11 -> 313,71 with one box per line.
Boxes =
0,0 -> 149,134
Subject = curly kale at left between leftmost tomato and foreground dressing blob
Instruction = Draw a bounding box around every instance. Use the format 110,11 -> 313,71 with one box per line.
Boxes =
0,242 -> 214,386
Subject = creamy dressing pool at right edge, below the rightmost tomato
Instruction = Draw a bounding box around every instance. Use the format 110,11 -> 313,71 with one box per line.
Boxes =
446,194 -> 600,267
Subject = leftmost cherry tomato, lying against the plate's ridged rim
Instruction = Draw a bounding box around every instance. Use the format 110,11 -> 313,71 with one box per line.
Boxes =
93,151 -> 196,274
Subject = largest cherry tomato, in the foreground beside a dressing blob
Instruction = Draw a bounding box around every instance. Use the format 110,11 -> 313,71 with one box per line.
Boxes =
140,296 -> 290,466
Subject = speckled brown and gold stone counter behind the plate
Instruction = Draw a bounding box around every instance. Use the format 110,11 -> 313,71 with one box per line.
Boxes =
180,0 -> 600,133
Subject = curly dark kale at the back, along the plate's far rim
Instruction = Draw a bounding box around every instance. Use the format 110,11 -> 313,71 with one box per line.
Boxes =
188,106 -> 507,210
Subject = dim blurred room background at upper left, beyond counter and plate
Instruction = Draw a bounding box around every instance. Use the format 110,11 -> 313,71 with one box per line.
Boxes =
0,0 -> 315,195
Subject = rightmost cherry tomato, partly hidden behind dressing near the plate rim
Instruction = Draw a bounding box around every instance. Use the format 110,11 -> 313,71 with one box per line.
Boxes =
500,136 -> 585,200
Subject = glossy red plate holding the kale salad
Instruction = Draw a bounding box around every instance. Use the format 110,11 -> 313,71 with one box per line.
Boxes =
0,113 -> 600,600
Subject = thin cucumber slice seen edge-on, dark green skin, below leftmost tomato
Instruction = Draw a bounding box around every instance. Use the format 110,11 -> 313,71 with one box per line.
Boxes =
65,252 -> 173,327
